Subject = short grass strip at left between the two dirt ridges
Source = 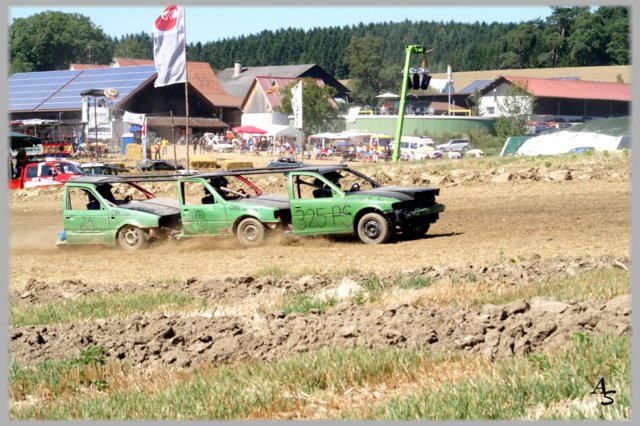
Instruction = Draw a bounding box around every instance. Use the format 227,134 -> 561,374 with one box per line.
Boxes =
9,292 -> 202,327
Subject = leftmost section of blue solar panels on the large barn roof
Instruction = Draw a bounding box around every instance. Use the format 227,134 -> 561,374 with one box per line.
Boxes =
9,70 -> 81,111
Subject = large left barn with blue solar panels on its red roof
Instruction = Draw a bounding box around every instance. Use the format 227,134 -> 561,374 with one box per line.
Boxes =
9,58 -> 241,148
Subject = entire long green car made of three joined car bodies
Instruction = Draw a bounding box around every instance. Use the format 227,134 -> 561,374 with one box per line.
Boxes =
58,165 -> 444,250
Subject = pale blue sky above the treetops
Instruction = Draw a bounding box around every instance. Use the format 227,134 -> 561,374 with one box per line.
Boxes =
8,5 -> 551,43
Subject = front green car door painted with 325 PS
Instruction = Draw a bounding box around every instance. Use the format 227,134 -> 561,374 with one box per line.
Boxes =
289,172 -> 353,234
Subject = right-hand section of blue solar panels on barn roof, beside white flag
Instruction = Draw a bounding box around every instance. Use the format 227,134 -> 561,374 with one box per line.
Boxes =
38,65 -> 156,110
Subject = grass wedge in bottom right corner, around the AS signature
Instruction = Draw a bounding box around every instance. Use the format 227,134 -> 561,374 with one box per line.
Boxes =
343,333 -> 631,420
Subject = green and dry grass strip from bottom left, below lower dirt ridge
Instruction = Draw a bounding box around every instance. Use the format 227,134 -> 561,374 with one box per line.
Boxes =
11,348 -> 440,419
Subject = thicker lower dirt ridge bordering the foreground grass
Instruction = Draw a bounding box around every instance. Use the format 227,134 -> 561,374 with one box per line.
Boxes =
9,295 -> 630,367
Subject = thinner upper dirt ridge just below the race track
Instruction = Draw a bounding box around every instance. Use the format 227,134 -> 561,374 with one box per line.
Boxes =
11,256 -> 629,306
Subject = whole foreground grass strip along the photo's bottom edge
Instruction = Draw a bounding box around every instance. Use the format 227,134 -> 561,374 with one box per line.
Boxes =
10,334 -> 630,420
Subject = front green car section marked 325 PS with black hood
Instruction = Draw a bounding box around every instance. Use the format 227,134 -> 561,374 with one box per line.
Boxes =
286,166 -> 444,244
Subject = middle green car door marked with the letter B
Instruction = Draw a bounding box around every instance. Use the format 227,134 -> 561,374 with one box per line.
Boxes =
179,179 -> 230,236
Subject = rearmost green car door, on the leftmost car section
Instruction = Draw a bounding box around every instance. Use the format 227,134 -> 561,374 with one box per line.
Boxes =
63,186 -> 114,244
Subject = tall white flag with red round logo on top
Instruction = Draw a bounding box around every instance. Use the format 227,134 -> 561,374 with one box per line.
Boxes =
153,5 -> 187,87
